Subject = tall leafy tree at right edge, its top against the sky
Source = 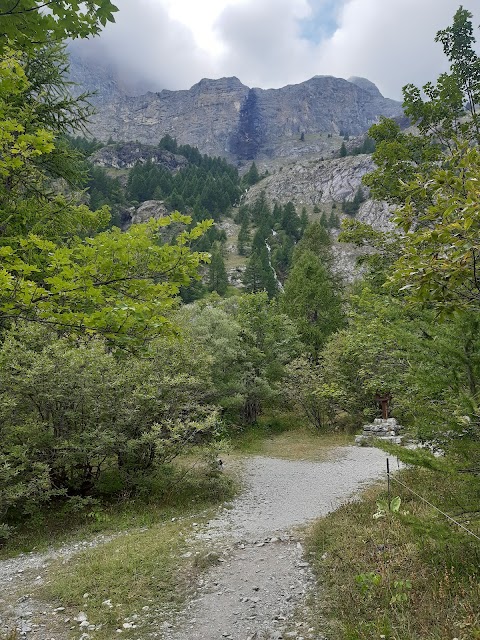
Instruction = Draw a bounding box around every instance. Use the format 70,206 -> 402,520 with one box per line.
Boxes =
365,8 -> 480,312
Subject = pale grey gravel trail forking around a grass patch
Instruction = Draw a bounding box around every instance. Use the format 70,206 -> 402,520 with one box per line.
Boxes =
0,447 -> 385,640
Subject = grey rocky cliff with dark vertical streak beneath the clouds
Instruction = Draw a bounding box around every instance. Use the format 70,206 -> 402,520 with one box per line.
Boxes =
72,53 -> 402,163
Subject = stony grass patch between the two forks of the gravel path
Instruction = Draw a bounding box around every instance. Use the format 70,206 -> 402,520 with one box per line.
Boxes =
38,514 -> 211,640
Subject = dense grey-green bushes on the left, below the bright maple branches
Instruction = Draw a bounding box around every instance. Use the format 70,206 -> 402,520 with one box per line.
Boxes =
0,325 -> 220,536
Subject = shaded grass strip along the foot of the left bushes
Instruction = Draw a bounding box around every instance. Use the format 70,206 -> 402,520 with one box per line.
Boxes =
0,459 -> 236,559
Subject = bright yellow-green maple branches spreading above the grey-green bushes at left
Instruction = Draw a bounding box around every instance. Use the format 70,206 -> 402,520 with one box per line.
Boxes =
0,213 -> 211,343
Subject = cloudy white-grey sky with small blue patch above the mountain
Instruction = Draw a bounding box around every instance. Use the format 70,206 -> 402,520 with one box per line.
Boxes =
71,0 -> 480,99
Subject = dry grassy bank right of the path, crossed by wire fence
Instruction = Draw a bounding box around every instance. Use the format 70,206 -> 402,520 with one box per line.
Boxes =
308,469 -> 480,640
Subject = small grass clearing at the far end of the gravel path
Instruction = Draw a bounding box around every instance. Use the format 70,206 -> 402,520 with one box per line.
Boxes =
232,413 -> 353,460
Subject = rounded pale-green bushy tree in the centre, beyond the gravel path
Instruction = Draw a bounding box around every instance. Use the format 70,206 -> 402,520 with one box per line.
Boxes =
182,293 -> 300,424
